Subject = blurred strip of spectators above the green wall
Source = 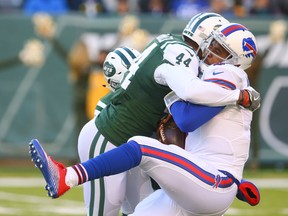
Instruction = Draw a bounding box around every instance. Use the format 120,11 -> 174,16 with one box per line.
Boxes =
0,0 -> 288,19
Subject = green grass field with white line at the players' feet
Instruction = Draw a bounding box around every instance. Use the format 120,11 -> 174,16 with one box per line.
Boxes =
0,166 -> 288,216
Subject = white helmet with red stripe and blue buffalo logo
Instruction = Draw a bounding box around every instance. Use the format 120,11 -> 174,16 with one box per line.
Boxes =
204,23 -> 257,70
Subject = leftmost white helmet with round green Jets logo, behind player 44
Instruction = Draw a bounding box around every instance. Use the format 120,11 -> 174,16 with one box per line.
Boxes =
103,47 -> 140,91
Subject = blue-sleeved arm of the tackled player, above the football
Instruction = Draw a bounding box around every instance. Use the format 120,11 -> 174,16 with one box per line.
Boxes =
169,101 -> 224,132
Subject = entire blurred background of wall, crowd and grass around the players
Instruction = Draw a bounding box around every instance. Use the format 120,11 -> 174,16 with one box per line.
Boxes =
0,0 -> 288,216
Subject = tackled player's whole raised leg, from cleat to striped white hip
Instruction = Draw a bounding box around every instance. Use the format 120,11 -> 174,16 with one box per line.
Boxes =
30,137 -> 237,215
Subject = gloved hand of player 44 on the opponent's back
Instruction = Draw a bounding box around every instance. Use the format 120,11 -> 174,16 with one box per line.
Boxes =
238,87 -> 261,112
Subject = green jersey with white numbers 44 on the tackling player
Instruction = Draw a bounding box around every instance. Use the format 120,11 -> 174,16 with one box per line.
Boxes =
95,34 -> 199,146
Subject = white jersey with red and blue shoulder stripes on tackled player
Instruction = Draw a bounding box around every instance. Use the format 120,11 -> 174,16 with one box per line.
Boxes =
186,64 -> 252,180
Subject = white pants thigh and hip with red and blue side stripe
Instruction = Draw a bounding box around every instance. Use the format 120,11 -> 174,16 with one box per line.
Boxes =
131,136 -> 237,215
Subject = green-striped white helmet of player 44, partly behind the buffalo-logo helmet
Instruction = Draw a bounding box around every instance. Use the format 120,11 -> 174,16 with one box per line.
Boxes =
182,13 -> 229,47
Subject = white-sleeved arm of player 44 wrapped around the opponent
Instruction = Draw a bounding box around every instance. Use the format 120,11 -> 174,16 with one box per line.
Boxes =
156,64 -> 240,106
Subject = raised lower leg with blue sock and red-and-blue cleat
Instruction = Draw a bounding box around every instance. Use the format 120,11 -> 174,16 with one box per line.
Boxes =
29,139 -> 142,198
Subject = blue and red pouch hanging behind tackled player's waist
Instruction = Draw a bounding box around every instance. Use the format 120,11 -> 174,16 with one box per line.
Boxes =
219,170 -> 260,206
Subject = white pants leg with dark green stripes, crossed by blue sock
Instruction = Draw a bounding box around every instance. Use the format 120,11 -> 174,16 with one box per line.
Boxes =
78,119 -> 126,216
